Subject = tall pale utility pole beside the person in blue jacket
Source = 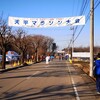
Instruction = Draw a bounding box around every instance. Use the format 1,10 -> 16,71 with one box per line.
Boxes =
90,0 -> 94,76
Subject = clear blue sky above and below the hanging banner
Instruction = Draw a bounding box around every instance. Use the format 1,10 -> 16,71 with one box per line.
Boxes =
0,0 -> 100,50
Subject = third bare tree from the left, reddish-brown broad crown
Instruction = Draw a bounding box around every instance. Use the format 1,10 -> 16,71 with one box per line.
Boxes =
31,35 -> 53,62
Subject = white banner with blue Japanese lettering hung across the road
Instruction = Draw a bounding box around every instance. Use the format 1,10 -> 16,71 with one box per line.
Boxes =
8,16 -> 85,28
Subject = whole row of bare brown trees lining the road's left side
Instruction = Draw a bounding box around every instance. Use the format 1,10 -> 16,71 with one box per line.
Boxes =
0,18 -> 56,69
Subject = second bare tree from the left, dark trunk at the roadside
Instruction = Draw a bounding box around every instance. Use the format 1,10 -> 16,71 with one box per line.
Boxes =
14,29 -> 30,65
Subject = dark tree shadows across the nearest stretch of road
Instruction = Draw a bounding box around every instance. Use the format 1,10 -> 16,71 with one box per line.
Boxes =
0,83 -> 95,100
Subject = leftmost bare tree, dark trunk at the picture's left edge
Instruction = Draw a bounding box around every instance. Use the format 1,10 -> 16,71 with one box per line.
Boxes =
0,18 -> 13,69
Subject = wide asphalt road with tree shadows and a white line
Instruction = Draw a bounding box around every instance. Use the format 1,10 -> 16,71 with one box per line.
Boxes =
0,60 -> 100,100
